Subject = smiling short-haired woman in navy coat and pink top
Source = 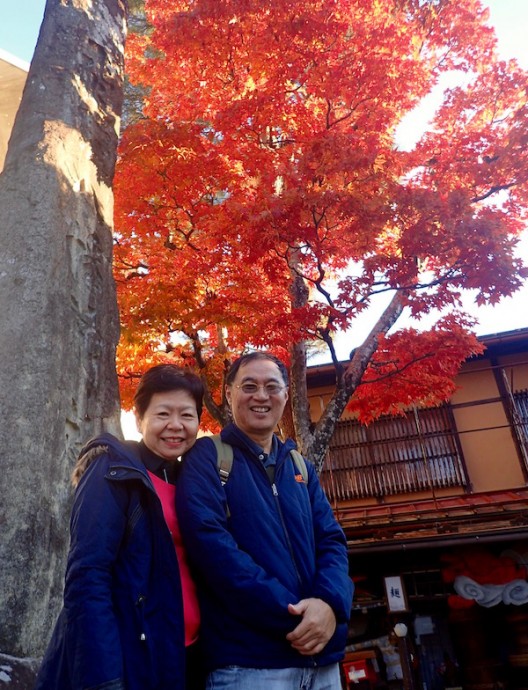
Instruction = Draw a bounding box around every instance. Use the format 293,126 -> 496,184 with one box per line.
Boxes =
35,364 -> 203,690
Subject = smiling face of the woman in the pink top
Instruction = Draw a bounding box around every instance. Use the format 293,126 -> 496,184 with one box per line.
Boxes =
136,390 -> 199,462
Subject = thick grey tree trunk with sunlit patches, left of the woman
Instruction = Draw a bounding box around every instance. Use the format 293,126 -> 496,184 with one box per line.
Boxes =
0,0 -> 126,656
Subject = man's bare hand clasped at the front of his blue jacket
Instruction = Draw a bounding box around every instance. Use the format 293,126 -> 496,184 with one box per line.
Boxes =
286,598 -> 336,656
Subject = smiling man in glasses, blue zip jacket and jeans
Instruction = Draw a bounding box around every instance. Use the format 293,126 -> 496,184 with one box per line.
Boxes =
177,352 -> 352,690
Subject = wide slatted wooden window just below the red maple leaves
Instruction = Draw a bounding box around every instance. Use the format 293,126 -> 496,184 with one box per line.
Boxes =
321,405 -> 467,501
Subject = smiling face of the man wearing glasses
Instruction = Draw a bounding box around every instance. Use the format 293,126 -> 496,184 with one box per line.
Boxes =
226,359 -> 288,445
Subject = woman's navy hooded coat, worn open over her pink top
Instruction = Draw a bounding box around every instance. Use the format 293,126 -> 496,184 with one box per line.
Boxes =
35,434 -> 185,690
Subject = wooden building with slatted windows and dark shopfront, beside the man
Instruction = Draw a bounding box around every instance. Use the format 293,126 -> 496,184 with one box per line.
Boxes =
308,329 -> 528,690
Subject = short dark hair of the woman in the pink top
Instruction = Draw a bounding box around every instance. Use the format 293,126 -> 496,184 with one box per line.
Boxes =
134,364 -> 204,419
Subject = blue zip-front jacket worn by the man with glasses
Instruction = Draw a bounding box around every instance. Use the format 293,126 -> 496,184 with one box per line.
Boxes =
176,424 -> 353,670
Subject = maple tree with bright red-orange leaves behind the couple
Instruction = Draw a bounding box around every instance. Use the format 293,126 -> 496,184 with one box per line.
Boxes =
115,0 -> 528,468
